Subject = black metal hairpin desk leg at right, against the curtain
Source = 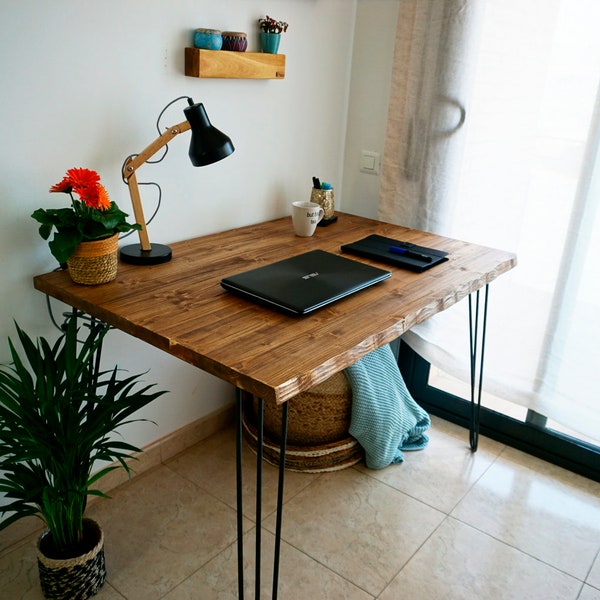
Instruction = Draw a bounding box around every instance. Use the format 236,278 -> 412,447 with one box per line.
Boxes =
469,284 -> 489,452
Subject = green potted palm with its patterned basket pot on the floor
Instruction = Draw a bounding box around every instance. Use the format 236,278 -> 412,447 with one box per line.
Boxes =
0,318 -> 164,599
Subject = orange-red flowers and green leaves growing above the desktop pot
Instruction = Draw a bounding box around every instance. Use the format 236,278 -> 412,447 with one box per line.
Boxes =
31,168 -> 141,264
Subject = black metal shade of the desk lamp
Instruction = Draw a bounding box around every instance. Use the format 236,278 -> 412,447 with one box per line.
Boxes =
183,103 -> 234,167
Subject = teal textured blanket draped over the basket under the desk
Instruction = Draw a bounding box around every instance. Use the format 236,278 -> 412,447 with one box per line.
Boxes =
344,345 -> 431,469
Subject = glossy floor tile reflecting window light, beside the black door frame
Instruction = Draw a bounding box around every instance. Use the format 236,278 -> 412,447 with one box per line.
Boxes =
452,448 -> 600,581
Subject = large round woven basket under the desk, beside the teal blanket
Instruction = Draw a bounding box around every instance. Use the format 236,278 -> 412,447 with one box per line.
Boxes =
242,373 -> 364,473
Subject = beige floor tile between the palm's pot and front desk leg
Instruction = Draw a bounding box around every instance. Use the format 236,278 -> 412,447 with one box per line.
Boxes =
86,466 -> 244,600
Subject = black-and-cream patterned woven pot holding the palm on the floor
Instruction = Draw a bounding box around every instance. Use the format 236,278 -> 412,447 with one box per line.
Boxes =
37,519 -> 106,600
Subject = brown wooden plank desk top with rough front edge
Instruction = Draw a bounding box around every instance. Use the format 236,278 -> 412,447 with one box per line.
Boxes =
34,213 -> 516,402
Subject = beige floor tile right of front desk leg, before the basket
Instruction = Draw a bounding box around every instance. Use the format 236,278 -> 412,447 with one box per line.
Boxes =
266,469 -> 444,596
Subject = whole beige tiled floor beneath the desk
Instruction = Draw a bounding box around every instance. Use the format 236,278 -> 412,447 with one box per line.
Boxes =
0,418 -> 600,600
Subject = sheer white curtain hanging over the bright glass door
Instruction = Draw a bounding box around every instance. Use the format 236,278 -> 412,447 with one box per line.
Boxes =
379,0 -> 600,440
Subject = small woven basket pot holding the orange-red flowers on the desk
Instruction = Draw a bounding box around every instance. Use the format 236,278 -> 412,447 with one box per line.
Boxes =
67,233 -> 119,285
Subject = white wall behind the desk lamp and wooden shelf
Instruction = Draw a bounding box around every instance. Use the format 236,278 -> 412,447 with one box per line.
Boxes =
0,0 -> 356,445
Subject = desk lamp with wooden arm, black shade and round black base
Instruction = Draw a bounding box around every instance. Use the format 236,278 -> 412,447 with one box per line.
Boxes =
120,98 -> 234,265
